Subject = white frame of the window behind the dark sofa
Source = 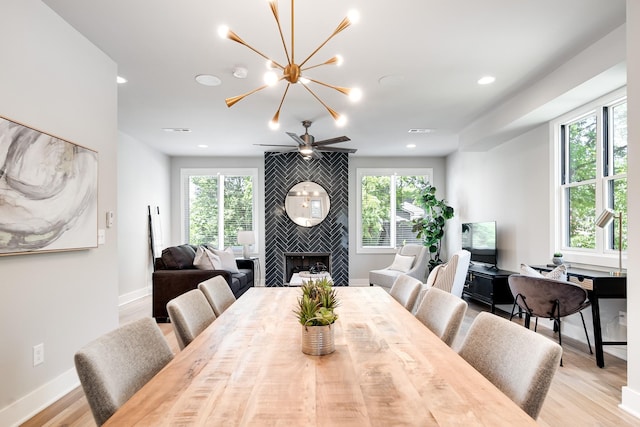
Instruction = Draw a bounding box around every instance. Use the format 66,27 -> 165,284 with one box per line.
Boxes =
180,168 -> 262,253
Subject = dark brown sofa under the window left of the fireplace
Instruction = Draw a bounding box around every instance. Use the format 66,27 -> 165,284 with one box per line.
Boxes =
152,244 -> 254,322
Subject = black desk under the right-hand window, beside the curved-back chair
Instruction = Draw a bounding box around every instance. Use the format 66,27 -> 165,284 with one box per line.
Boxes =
531,265 -> 627,368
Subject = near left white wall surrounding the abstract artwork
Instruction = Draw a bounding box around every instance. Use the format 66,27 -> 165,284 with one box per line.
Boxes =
0,0 -> 118,426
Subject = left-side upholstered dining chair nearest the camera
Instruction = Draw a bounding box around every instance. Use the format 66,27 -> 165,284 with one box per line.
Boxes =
74,317 -> 173,425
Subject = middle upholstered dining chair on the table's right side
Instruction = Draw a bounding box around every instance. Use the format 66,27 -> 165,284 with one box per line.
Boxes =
415,288 -> 468,347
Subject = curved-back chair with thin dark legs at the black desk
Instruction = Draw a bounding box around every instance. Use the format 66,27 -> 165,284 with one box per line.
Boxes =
509,274 -> 593,366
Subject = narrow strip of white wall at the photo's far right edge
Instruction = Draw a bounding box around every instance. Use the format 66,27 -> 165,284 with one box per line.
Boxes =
622,0 -> 640,417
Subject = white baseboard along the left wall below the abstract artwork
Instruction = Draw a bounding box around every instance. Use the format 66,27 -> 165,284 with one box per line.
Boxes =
0,368 -> 80,426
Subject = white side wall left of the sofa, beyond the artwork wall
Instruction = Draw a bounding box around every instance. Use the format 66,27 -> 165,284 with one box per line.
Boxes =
116,133 -> 171,304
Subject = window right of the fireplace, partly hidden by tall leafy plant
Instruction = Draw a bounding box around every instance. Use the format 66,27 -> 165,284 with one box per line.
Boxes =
357,169 -> 433,253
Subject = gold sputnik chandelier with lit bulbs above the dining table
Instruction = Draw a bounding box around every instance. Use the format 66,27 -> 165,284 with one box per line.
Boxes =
218,0 -> 362,129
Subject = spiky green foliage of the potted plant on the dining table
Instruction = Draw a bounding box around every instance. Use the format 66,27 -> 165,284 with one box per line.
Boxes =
293,278 -> 340,326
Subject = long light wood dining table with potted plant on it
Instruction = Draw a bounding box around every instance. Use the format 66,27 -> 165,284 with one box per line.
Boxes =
105,287 -> 536,427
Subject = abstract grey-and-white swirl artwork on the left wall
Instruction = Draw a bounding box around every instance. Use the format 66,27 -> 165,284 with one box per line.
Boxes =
0,117 -> 98,255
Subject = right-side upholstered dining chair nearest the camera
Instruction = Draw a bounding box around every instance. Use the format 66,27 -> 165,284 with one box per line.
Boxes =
459,312 -> 562,419
